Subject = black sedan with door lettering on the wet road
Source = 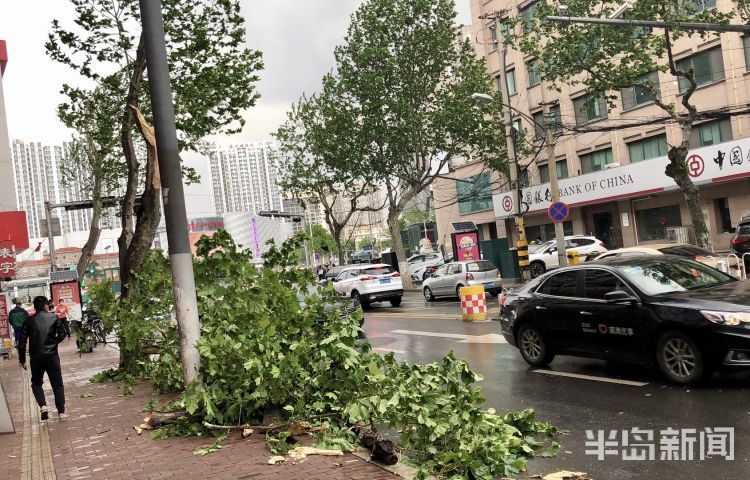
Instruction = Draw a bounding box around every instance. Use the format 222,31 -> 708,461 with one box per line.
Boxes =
500,256 -> 750,384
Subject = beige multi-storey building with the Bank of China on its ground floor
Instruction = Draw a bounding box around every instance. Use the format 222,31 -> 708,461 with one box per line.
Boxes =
434,0 -> 750,251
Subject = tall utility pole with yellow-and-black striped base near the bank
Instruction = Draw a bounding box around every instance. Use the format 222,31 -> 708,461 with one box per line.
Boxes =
473,9 -> 530,282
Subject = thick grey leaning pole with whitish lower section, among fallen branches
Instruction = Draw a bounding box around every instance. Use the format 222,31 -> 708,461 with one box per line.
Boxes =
140,0 -> 200,387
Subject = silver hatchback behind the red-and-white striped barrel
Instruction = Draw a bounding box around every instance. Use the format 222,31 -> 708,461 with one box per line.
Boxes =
422,260 -> 503,301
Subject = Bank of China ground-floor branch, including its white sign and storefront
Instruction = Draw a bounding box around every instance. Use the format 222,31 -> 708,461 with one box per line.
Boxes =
493,138 -> 750,251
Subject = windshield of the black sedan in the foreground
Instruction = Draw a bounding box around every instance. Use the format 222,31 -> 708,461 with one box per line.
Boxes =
617,258 -> 734,295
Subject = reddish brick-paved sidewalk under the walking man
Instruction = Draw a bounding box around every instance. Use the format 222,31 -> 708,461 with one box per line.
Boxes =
0,340 -> 399,480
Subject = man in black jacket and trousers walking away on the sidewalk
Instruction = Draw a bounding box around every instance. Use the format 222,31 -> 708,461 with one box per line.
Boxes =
18,296 -> 67,420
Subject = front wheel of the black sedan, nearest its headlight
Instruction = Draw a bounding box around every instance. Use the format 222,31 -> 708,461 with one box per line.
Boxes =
656,331 -> 705,385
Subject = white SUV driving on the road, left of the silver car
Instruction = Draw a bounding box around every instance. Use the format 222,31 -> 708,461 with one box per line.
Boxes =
332,263 -> 404,309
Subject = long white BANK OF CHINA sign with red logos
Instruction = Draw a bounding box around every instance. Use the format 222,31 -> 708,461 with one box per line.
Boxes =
492,134 -> 750,218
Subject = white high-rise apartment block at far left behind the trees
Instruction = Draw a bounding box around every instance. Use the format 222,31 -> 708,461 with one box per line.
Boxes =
12,140 -> 100,238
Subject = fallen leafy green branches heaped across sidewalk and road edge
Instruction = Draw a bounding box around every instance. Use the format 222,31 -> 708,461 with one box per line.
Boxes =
94,232 -> 556,479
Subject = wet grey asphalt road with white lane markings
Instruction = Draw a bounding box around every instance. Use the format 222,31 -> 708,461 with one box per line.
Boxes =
364,293 -> 750,480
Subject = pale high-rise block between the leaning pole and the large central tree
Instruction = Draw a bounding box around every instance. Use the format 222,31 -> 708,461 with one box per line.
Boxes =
209,142 -> 282,215
